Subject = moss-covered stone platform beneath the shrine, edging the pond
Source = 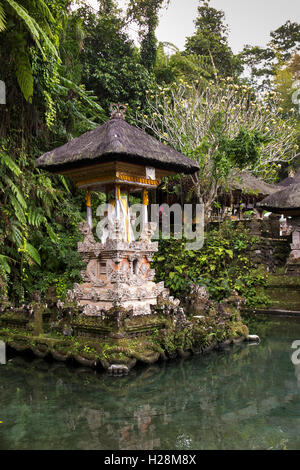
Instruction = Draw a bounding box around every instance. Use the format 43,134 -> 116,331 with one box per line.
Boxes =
0,300 -> 248,373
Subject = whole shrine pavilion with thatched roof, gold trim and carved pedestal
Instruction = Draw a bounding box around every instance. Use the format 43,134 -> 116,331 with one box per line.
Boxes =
36,103 -> 199,316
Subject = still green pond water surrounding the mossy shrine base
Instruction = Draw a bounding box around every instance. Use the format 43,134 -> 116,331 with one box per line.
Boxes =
0,319 -> 300,450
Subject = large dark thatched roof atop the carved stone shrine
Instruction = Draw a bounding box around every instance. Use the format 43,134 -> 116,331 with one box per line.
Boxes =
36,118 -> 199,174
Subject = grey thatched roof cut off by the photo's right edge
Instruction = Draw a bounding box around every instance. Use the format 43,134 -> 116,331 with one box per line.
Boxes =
258,183 -> 300,213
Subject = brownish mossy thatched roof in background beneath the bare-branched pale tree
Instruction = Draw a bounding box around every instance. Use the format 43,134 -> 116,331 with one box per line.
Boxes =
229,170 -> 278,196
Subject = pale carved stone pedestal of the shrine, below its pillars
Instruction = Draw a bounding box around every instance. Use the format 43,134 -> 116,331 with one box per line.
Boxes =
74,221 -> 168,316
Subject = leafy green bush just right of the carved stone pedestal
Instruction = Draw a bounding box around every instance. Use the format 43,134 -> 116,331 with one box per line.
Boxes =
154,222 -> 268,306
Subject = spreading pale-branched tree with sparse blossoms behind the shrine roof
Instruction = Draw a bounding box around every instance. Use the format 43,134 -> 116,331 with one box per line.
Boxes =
137,77 -> 298,210
